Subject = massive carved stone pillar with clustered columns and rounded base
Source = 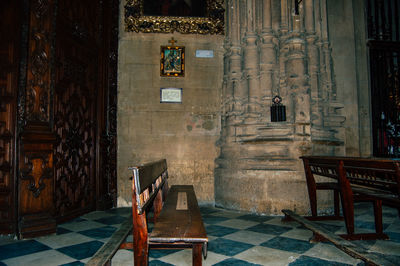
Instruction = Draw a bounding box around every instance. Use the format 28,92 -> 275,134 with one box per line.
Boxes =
215,0 -> 344,214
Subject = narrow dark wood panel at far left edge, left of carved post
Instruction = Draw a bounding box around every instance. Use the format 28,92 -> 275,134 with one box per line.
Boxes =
0,0 -> 20,234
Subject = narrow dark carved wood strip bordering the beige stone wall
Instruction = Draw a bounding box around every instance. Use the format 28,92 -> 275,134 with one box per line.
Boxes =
97,0 -> 119,209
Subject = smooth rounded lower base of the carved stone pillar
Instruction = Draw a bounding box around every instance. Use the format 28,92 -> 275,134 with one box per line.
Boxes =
215,170 -> 329,215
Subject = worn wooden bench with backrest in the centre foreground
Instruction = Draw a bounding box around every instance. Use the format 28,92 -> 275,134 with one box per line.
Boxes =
131,159 -> 208,265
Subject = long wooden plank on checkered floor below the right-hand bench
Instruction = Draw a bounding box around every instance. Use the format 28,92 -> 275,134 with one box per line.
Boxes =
282,210 -> 395,266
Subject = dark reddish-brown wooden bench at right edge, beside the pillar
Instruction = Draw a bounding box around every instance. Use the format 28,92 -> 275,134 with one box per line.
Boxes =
301,156 -> 400,240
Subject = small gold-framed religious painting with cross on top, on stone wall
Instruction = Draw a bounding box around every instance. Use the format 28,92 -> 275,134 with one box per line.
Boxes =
160,46 -> 185,77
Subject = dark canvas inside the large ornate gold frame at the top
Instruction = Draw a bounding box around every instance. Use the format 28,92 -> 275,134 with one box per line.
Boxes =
143,0 -> 206,17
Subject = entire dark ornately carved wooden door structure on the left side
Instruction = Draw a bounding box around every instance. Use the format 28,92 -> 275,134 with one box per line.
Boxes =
0,0 -> 119,238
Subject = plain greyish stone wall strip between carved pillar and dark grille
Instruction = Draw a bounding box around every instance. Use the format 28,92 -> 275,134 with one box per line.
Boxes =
328,0 -> 373,157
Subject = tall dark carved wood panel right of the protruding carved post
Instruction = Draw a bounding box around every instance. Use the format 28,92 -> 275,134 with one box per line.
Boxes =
54,1 -> 101,221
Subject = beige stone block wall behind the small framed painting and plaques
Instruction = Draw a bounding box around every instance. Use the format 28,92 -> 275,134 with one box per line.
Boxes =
118,1 -> 224,206
